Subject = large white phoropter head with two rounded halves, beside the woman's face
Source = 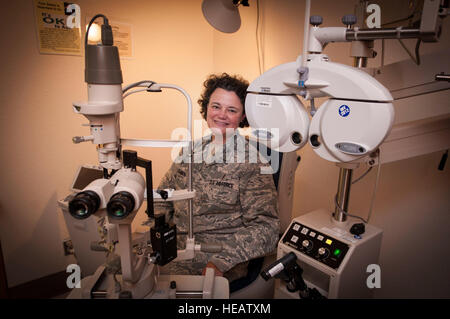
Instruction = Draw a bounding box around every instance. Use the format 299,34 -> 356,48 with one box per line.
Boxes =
245,54 -> 394,162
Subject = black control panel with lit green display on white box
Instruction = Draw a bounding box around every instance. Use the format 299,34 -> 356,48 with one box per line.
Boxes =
282,222 -> 349,269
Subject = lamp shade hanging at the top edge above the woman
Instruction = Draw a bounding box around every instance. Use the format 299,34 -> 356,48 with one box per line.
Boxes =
202,0 -> 249,33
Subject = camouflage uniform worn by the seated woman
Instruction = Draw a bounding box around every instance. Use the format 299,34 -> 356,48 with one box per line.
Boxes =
155,130 -> 279,279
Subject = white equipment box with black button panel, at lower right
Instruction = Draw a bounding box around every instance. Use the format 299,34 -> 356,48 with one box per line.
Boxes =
275,210 -> 382,299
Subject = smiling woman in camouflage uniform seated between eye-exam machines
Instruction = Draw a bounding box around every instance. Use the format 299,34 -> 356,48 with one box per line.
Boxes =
155,73 -> 279,282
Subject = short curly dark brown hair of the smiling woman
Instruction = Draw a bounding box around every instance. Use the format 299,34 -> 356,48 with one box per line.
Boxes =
197,73 -> 250,127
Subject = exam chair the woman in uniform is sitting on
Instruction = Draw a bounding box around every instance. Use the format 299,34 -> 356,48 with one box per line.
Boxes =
230,152 -> 301,299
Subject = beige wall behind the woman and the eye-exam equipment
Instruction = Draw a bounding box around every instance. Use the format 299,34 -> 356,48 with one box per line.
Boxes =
0,0 -> 450,298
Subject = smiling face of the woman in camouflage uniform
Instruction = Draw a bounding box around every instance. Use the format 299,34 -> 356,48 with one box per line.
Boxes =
206,88 -> 245,141
